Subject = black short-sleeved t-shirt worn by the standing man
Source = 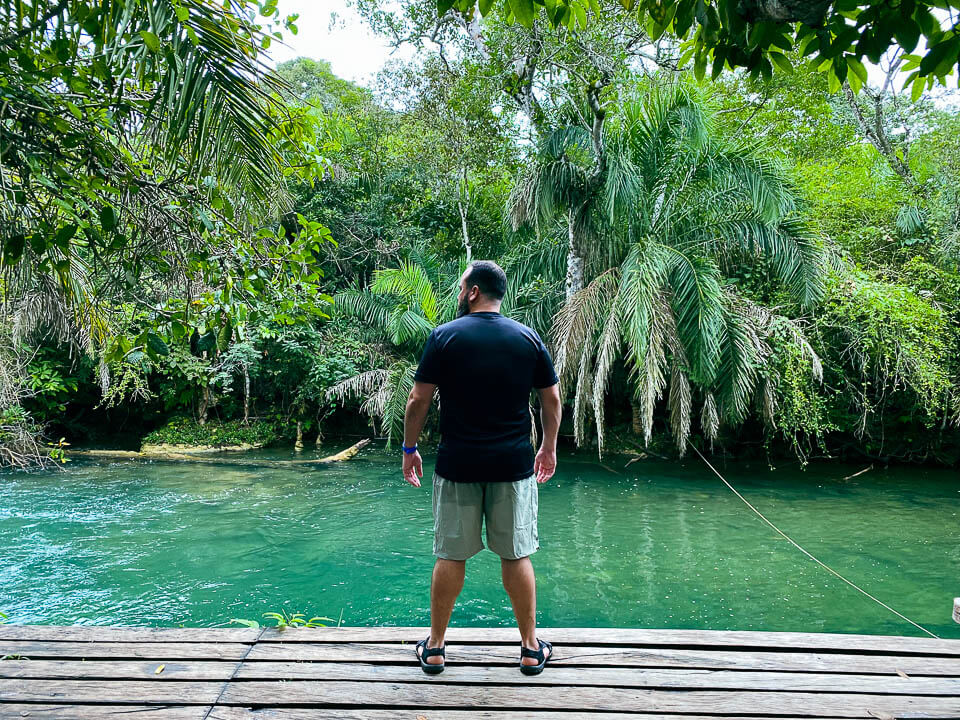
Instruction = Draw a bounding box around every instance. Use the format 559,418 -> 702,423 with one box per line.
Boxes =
415,312 -> 557,482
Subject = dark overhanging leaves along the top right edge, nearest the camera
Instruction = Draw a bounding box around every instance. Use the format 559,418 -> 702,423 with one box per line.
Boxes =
446,0 -> 960,97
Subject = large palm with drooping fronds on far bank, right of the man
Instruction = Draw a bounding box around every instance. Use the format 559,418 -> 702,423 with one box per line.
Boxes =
519,85 -> 823,452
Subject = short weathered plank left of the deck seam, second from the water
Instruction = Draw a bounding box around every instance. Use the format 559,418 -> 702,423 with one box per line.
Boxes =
0,640 -> 250,660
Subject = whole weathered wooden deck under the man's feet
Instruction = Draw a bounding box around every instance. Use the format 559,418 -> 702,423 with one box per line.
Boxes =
0,625 -> 960,720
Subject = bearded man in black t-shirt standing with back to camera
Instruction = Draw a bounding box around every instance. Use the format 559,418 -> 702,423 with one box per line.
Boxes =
403,260 -> 560,675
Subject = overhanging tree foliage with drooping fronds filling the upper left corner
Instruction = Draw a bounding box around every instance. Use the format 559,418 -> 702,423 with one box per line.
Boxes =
0,0 -> 328,464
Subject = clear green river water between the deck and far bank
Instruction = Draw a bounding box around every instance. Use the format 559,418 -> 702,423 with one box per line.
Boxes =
0,450 -> 960,638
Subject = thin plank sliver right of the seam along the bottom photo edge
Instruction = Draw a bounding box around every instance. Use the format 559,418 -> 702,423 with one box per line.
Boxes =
208,706 -> 841,720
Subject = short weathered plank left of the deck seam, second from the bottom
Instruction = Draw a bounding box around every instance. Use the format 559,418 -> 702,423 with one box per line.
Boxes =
0,679 -> 220,705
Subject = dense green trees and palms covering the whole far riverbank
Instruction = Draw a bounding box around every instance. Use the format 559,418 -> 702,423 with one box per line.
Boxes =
0,0 -> 960,466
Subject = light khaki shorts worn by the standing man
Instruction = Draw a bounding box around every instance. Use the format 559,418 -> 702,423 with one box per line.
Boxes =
433,473 -> 540,560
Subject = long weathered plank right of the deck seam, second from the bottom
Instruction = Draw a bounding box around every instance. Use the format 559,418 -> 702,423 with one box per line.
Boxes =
219,680 -> 960,718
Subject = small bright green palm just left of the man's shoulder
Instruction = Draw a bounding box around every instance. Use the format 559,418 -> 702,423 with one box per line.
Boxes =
327,248 -> 465,444
